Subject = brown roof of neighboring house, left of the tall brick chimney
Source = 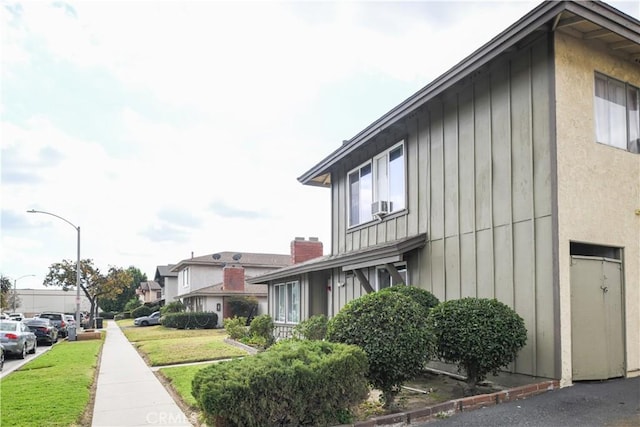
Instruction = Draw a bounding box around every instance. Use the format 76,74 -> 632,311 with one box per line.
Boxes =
171,252 -> 291,272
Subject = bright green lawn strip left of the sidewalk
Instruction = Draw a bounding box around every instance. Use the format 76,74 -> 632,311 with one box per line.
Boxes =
0,340 -> 104,427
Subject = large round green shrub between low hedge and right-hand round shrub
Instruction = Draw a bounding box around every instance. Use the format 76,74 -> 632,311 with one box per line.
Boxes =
326,292 -> 433,407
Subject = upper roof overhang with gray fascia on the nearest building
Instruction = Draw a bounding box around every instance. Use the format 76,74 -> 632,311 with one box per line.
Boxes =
298,1 -> 640,187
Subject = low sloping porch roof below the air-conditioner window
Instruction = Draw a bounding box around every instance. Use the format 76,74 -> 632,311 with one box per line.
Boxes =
247,233 -> 427,283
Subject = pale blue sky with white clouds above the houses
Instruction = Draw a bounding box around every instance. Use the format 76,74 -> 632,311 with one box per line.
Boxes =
0,1 -> 640,288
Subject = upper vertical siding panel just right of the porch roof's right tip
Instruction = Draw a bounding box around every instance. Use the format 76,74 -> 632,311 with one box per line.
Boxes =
429,103 -> 444,239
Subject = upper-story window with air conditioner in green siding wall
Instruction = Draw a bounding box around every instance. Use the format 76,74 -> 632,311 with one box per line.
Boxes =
348,142 -> 406,227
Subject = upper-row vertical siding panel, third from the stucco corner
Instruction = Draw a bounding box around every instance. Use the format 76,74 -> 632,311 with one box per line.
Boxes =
491,68 -> 511,226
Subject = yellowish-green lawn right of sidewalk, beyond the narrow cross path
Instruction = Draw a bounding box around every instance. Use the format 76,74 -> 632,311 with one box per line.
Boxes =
118,319 -> 247,366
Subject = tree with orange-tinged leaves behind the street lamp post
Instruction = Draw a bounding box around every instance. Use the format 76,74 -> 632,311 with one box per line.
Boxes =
43,259 -> 132,323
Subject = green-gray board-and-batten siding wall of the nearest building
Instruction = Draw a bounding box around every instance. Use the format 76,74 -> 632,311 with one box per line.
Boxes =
332,36 -> 557,378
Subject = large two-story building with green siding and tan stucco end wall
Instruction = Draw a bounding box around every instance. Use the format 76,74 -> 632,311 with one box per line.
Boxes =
248,1 -> 640,385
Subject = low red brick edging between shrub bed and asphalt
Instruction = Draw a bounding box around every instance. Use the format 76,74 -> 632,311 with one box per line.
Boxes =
353,380 -> 560,427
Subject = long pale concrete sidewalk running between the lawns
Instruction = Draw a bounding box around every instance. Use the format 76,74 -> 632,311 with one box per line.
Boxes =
92,321 -> 192,427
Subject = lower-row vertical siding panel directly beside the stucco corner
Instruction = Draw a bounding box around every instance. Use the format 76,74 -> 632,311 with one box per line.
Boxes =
535,216 -> 555,378
